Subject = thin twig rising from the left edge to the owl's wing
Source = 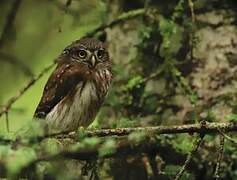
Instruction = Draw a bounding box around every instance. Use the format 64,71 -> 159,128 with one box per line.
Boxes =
0,62 -> 55,117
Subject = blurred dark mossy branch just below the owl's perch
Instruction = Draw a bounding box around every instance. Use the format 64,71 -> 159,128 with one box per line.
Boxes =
19,138 -> 167,172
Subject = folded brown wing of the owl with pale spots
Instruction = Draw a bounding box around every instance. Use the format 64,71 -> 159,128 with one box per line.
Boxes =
34,64 -> 83,118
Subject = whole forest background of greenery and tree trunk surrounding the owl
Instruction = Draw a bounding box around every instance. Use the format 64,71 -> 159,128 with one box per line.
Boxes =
0,0 -> 237,179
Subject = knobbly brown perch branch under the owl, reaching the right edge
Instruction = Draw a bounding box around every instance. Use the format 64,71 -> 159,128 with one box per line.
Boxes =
53,122 -> 237,138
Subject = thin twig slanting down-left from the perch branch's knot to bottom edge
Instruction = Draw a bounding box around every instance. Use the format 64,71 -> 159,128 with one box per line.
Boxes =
175,135 -> 204,180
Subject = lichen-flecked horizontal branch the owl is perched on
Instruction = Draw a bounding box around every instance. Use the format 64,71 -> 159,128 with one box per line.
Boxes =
0,122 -> 234,143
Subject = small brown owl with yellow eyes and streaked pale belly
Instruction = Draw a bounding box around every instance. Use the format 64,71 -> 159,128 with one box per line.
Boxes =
34,38 -> 112,131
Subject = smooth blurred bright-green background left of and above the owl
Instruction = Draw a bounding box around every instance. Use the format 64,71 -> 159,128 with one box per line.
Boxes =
0,0 -> 107,131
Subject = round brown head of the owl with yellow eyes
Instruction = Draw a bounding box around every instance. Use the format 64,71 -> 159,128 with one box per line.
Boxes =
63,38 -> 109,68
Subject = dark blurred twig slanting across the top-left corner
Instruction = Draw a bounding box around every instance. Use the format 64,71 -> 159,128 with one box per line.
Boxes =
0,0 -> 21,48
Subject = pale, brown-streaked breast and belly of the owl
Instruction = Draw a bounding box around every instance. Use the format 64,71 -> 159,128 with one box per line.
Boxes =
46,81 -> 103,131
